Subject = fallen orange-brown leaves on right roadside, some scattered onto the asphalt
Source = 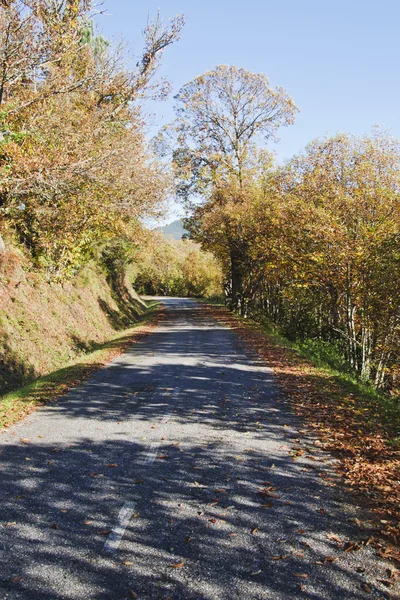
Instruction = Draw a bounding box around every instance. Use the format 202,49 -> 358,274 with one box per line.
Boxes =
203,306 -> 400,552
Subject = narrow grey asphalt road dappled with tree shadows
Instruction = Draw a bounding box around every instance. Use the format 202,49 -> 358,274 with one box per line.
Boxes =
0,299 -> 399,600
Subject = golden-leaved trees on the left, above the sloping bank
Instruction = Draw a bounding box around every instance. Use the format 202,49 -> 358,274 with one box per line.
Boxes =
0,0 -> 183,281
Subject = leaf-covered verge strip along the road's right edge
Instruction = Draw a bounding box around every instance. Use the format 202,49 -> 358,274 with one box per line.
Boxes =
203,303 -> 400,563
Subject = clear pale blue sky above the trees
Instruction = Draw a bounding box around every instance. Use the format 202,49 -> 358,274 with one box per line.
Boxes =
98,0 -> 400,164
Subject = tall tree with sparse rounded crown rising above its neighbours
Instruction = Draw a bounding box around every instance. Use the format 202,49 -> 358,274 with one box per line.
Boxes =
167,65 -> 297,309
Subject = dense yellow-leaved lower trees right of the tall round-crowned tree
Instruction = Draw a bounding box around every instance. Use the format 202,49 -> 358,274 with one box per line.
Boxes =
234,132 -> 400,387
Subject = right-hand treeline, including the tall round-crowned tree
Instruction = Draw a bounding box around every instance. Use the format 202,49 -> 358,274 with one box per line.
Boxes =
164,66 -> 400,392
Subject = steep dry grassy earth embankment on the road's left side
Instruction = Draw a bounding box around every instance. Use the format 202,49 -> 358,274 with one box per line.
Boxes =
0,251 -> 146,396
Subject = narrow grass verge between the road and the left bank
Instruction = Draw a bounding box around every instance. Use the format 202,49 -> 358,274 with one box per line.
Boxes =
0,302 -> 163,429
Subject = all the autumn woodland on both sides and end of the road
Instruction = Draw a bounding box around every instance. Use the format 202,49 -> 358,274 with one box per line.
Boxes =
0,0 -> 400,394
